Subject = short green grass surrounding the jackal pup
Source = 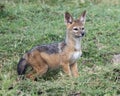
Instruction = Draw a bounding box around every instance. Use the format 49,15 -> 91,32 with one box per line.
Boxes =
0,0 -> 120,96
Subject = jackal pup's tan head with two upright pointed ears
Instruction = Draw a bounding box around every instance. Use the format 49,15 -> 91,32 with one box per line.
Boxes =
64,11 -> 86,38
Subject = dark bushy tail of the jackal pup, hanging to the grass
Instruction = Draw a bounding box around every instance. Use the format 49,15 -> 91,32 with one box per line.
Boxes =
17,56 -> 27,75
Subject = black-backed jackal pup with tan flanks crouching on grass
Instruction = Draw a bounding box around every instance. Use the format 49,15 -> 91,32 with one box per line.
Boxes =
17,11 -> 86,80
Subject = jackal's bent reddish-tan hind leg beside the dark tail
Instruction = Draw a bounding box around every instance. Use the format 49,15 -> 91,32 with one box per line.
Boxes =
27,50 -> 48,79
